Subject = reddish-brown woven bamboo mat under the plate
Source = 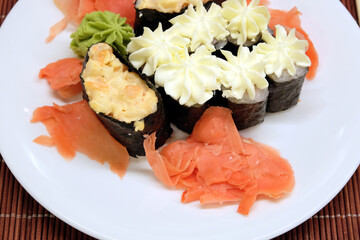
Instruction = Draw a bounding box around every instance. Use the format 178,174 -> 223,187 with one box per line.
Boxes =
0,0 -> 360,240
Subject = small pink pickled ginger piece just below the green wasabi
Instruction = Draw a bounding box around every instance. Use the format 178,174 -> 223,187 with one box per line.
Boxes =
39,58 -> 83,98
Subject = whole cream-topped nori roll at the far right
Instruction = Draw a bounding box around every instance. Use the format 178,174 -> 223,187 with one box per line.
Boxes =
256,25 -> 311,112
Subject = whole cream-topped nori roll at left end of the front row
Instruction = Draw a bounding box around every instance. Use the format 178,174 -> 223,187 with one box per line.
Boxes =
155,45 -> 221,133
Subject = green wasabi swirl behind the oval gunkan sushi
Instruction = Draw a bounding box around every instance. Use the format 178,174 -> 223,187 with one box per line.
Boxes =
70,11 -> 134,57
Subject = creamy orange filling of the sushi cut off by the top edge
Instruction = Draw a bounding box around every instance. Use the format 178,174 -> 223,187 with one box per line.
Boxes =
135,0 -> 210,13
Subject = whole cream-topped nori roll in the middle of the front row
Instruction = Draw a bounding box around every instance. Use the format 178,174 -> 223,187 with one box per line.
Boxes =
220,47 -> 269,130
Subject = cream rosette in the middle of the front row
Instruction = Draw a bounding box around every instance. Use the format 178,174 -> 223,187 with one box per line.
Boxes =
219,47 -> 268,100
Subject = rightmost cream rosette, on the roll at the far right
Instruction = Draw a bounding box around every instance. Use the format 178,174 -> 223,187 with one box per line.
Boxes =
255,25 -> 311,78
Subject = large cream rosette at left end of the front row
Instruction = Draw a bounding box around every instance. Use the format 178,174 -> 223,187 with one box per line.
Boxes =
155,46 -> 221,107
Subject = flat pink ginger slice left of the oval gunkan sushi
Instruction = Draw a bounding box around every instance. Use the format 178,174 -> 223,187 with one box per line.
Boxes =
31,100 -> 129,178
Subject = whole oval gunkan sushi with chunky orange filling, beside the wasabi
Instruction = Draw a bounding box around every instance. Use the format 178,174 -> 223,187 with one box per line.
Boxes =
80,43 -> 172,157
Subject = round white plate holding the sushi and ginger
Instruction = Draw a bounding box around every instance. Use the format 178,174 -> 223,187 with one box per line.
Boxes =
0,0 -> 360,239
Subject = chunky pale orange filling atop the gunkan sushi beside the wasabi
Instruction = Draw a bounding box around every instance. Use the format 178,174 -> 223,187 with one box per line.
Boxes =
82,43 -> 158,131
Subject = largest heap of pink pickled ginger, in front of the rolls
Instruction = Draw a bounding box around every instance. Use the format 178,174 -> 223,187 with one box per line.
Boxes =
144,107 -> 295,215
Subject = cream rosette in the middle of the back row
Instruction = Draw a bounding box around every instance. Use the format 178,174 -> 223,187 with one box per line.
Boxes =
170,1 -> 229,52
